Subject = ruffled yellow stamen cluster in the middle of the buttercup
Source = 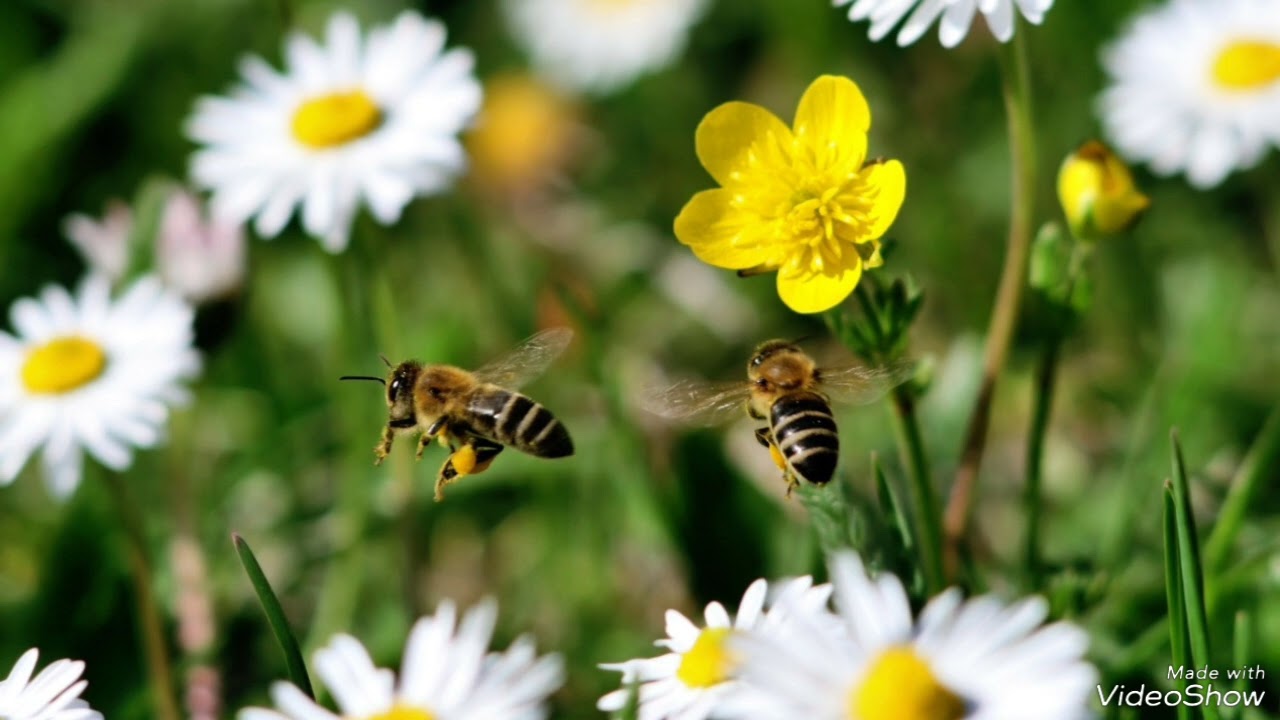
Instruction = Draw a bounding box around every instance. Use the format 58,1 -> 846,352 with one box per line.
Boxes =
782,182 -> 874,275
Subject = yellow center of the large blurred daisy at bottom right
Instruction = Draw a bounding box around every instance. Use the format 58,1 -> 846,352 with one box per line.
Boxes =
849,647 -> 965,720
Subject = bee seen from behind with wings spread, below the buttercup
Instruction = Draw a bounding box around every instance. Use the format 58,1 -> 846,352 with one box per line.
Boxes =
645,340 -> 914,497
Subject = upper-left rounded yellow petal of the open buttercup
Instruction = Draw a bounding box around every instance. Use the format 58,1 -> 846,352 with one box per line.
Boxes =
695,101 -> 791,186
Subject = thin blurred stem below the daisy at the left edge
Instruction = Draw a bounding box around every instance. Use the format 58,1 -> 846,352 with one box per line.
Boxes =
105,471 -> 180,720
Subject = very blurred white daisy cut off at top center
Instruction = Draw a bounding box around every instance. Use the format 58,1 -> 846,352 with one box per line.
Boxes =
502,0 -> 707,94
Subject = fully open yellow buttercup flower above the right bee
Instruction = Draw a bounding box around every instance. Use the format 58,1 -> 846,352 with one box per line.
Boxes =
676,76 -> 906,313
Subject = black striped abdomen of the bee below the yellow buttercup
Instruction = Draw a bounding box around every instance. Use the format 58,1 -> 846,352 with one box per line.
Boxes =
769,392 -> 840,486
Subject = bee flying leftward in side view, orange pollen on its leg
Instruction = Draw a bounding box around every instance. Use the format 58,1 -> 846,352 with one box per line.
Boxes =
342,328 -> 573,502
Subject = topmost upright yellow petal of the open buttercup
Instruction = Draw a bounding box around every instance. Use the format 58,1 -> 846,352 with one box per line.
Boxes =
794,76 -> 872,174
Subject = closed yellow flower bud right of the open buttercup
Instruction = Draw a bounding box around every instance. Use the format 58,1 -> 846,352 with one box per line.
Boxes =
1057,140 -> 1151,240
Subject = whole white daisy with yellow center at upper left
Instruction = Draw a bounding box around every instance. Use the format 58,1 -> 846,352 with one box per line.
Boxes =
187,12 -> 480,252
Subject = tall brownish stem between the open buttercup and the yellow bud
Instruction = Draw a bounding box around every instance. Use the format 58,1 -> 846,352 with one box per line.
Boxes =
943,32 -> 1036,575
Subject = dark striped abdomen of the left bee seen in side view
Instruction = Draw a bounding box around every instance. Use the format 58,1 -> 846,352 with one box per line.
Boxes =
467,386 -> 573,457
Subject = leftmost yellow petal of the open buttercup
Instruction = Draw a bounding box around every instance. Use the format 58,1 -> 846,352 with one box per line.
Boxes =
675,188 -> 771,270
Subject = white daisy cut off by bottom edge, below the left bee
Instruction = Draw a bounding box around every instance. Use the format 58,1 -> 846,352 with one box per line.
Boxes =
239,602 -> 563,720
